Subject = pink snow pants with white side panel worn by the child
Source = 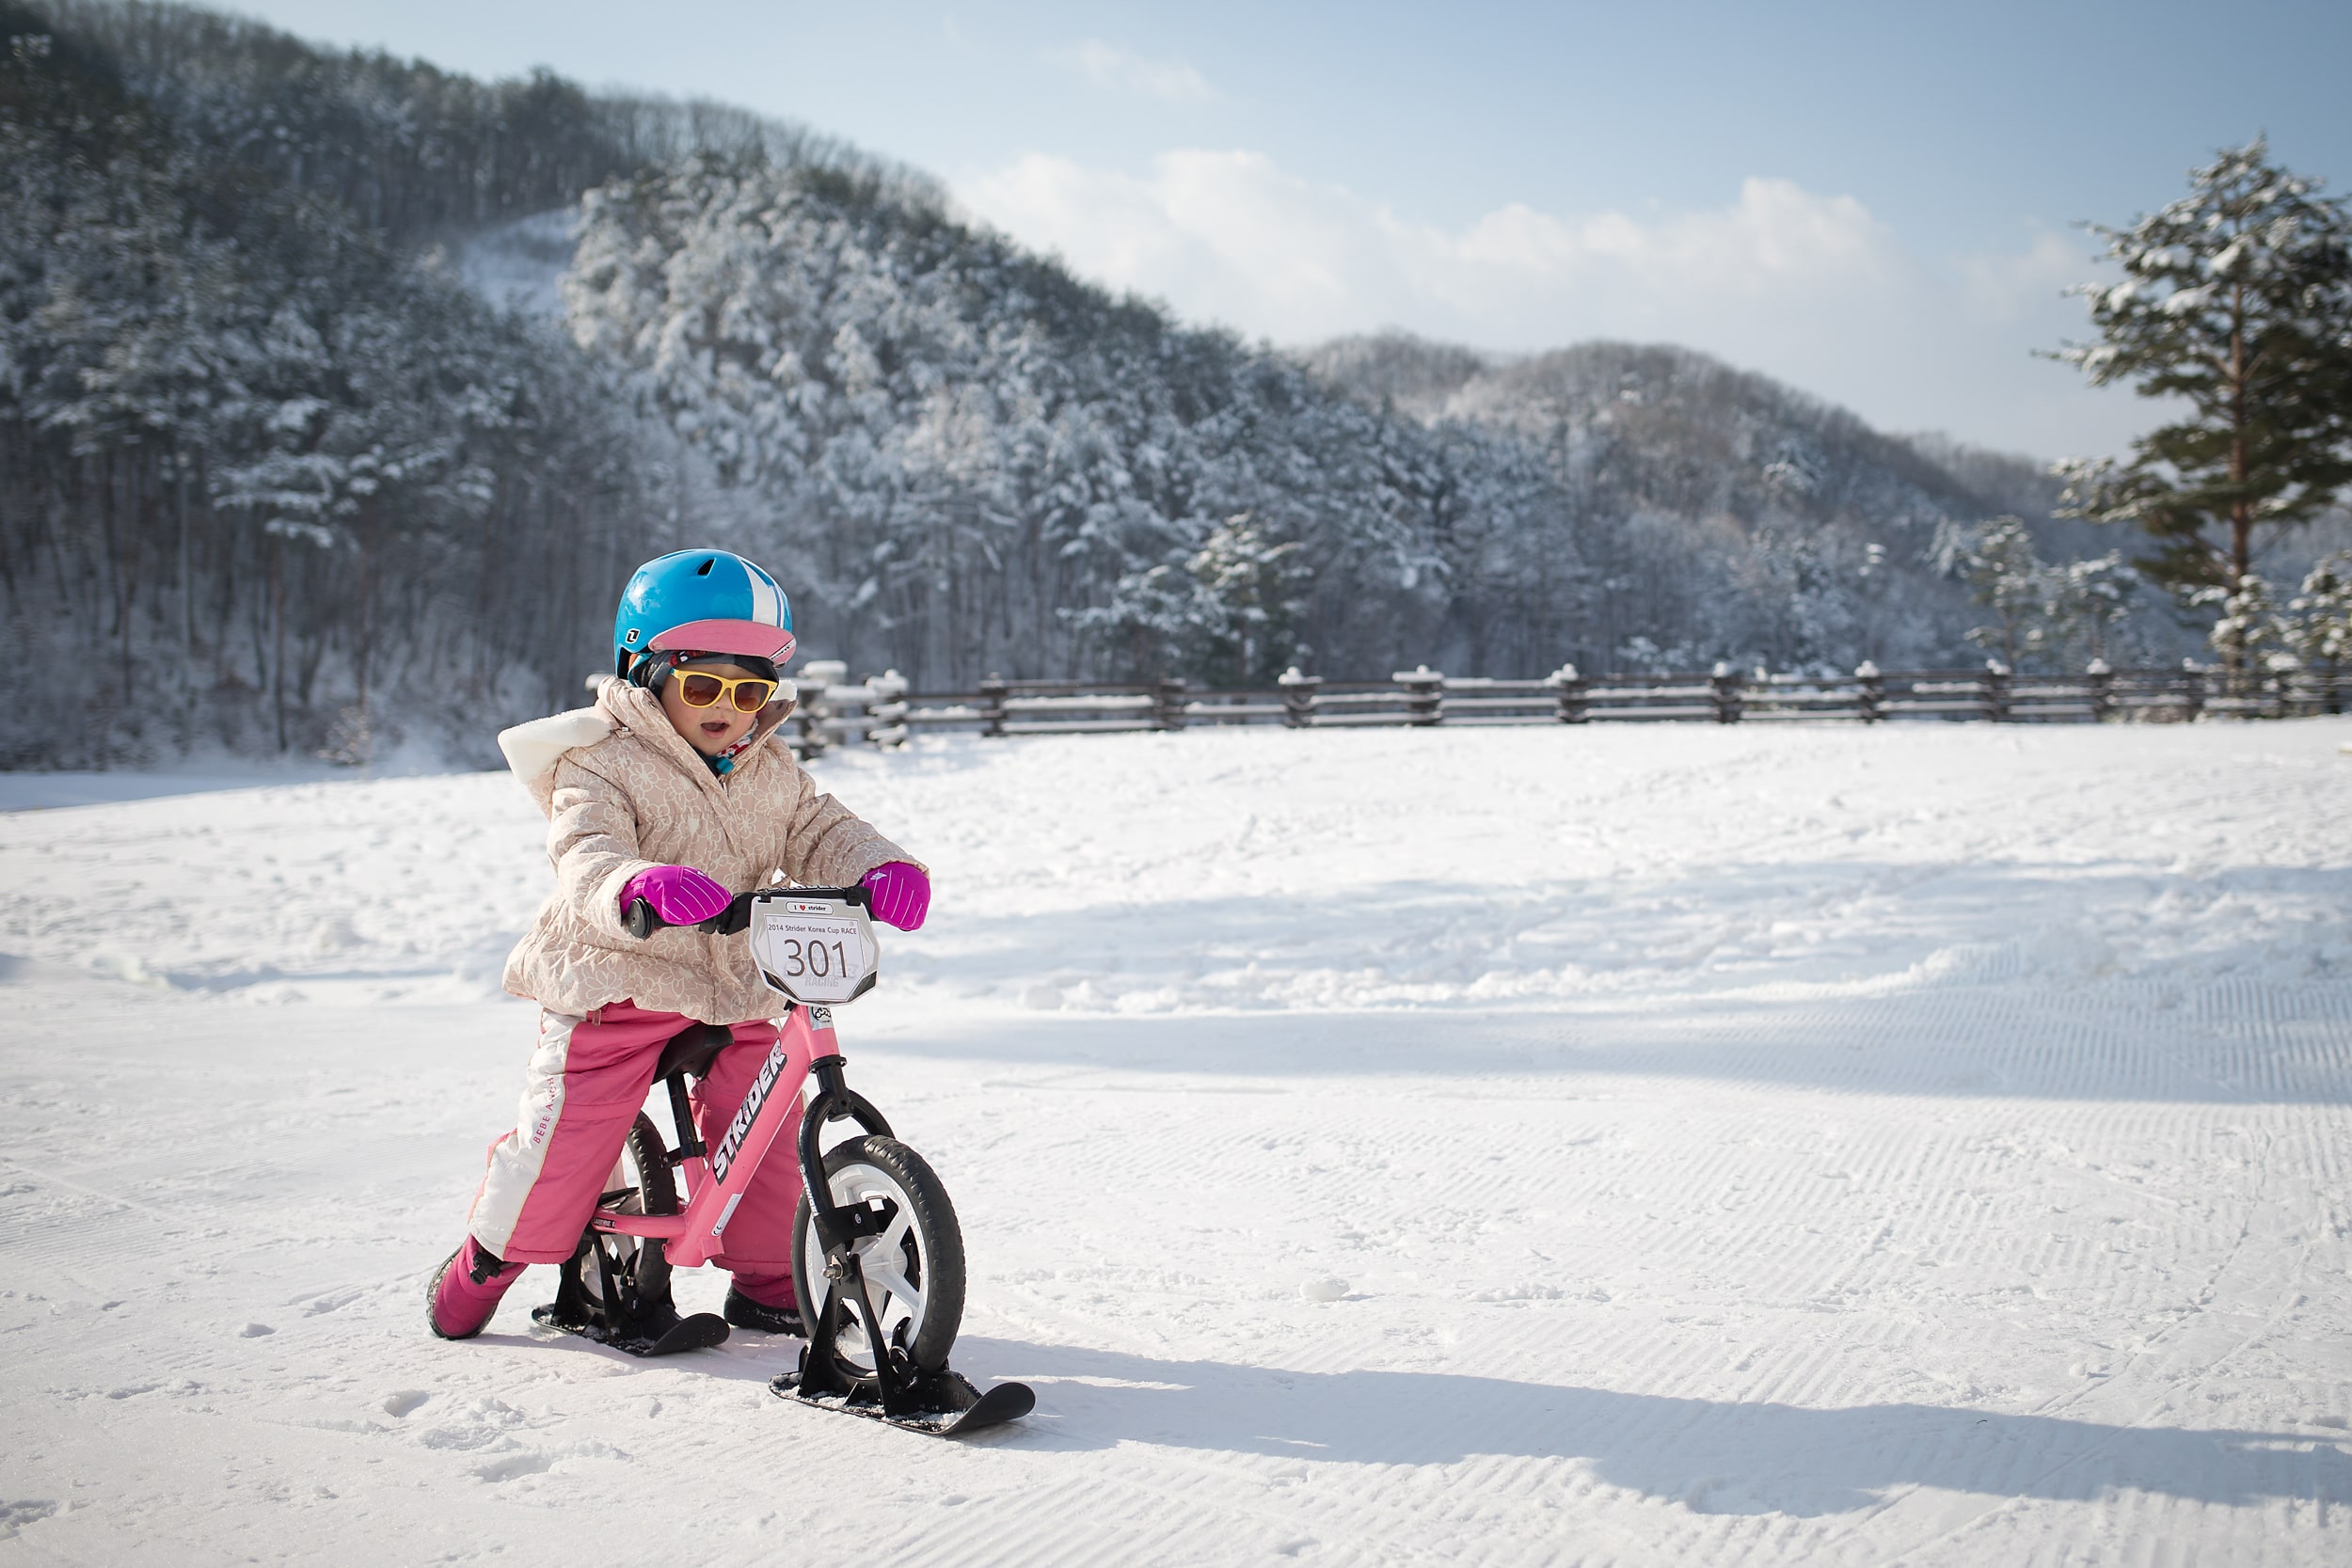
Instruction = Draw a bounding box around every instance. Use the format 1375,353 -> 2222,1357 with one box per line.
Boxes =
466,1002 -> 807,1279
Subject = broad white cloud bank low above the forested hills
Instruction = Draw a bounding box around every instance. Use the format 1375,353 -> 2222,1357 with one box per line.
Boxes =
958,150 -> 2150,456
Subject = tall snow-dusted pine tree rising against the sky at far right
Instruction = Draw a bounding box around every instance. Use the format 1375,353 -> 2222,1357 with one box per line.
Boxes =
2056,128 -> 2352,660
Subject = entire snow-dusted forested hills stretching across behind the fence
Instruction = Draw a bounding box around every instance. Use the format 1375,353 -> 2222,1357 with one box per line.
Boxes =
0,0 -> 2296,767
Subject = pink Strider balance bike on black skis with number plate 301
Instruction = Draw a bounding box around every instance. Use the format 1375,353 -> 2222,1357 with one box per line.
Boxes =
532,886 -> 1038,1436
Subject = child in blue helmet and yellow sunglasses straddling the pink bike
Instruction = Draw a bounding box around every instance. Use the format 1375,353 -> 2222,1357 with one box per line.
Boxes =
428,550 -> 931,1340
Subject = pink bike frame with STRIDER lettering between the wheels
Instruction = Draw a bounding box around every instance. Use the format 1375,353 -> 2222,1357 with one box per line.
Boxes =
588,1004 -> 892,1270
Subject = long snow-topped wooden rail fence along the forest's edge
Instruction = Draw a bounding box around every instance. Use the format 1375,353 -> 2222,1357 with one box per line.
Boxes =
795,660 -> 2352,754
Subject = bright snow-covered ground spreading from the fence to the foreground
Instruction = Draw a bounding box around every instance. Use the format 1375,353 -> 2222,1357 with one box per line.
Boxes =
0,721 -> 2352,1566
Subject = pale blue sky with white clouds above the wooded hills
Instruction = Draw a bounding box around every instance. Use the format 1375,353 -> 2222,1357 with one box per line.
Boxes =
212,0 -> 2352,458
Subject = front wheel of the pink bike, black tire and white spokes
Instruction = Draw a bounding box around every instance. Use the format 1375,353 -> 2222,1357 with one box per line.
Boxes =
793,1135 -> 964,1380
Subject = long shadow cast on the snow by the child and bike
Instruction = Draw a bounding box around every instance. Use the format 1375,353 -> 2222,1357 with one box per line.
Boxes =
958,1338 -> 2352,1516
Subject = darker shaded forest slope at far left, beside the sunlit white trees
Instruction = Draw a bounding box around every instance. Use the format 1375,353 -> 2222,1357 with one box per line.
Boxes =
0,5 -> 908,767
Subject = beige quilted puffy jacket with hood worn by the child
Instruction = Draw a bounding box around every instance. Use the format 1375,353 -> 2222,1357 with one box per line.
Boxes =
499,679 -> 913,1022
